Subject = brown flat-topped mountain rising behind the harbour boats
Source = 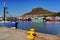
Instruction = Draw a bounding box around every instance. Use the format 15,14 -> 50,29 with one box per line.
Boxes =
23,8 -> 54,17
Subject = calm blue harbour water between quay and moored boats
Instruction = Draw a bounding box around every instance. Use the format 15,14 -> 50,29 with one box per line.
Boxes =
0,21 -> 60,36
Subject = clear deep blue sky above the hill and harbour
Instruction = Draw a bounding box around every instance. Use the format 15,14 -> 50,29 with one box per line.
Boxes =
0,0 -> 60,16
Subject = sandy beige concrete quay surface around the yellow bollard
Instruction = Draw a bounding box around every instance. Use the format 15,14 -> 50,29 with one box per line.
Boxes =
0,27 -> 60,40
